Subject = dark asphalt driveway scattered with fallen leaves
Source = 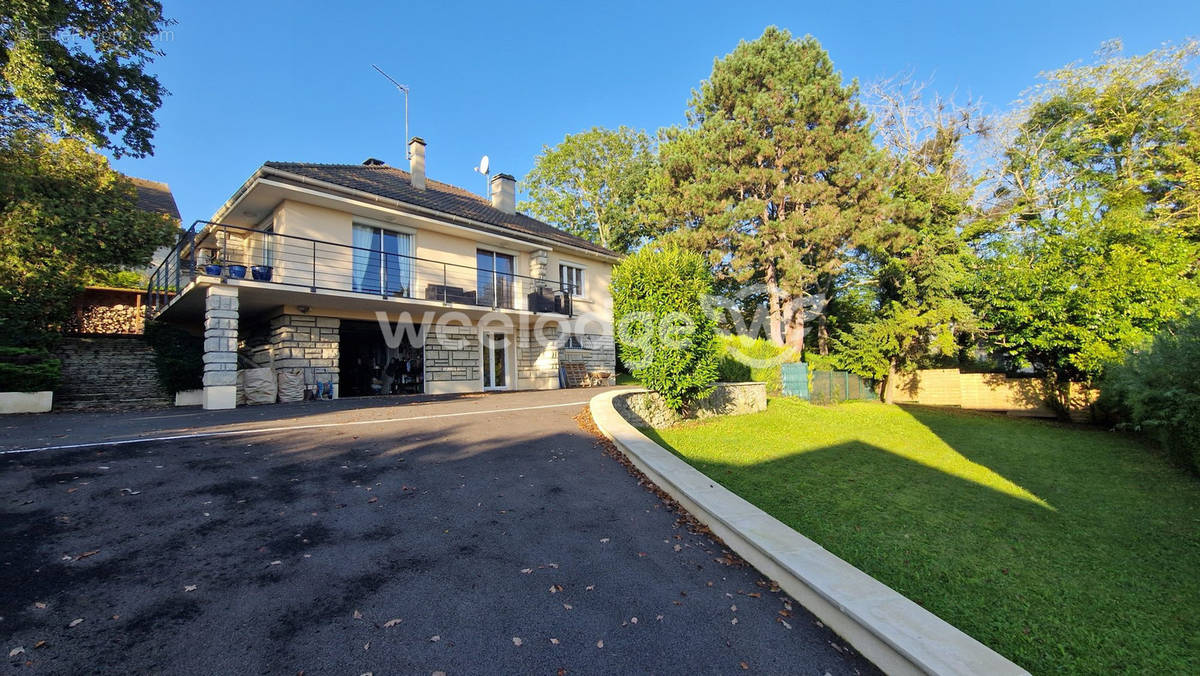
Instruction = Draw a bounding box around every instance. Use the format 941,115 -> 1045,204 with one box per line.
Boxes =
0,390 -> 875,675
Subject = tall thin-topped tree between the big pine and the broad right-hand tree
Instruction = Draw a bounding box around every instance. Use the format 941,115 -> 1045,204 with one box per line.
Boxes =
836,79 -> 976,379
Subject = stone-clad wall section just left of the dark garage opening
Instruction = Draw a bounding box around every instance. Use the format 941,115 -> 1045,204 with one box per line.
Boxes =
264,315 -> 342,388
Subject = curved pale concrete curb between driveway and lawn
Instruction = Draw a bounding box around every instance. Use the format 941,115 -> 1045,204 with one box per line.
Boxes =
590,390 -> 1028,675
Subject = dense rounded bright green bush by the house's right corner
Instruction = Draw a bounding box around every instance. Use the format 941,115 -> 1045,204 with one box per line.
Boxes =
612,247 -> 718,412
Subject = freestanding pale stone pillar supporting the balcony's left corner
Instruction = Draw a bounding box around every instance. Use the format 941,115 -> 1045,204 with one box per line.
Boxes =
204,285 -> 238,408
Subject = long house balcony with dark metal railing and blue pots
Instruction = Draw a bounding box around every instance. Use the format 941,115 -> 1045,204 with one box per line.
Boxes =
146,221 -> 571,316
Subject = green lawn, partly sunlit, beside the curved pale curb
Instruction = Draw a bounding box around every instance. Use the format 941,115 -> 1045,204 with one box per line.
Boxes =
653,399 -> 1200,674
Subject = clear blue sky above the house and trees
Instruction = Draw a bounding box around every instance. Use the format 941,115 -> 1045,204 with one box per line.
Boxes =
115,0 -> 1200,223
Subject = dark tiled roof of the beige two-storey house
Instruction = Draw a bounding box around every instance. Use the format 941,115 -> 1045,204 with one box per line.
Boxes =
263,162 -> 617,256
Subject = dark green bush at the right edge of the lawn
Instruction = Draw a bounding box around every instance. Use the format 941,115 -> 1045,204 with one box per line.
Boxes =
1100,316 -> 1200,473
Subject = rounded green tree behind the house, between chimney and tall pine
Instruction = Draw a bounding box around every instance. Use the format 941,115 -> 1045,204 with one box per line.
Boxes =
521,127 -> 656,253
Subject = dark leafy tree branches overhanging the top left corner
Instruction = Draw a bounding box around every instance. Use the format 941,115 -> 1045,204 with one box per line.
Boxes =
0,0 -> 173,157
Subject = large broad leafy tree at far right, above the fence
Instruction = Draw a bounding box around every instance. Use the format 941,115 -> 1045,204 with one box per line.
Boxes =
973,43 -> 1200,382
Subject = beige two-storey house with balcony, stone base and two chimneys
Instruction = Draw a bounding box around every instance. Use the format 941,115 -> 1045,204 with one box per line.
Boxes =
149,138 -> 618,408
